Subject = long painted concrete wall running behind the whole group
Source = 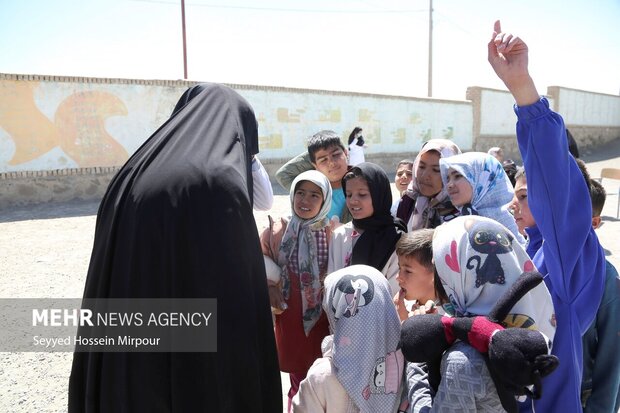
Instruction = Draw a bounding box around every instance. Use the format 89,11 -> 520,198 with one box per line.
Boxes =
0,74 -> 620,208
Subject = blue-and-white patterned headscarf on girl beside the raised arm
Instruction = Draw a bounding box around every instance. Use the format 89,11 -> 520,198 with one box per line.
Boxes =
439,152 -> 525,245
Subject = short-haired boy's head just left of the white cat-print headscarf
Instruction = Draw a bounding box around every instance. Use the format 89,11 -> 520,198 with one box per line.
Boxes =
394,229 -> 448,321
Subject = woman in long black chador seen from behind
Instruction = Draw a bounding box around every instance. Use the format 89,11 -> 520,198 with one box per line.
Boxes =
69,84 -> 282,413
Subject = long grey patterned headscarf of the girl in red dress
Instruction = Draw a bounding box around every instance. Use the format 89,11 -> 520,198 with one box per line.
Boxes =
278,171 -> 332,335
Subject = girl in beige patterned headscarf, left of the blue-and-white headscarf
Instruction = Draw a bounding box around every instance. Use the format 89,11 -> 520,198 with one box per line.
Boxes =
396,139 -> 461,232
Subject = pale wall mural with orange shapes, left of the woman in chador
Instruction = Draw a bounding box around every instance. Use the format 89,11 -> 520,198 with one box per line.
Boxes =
0,80 -> 178,172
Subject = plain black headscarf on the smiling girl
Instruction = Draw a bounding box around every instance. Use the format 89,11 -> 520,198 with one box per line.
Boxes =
342,162 -> 407,271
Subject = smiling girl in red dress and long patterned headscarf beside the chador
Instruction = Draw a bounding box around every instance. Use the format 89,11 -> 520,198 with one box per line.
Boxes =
261,171 -> 332,410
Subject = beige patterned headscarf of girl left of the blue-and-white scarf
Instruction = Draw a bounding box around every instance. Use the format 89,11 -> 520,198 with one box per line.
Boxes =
398,139 -> 461,231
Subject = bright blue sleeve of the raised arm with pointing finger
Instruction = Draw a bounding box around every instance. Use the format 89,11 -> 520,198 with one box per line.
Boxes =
515,98 -> 605,320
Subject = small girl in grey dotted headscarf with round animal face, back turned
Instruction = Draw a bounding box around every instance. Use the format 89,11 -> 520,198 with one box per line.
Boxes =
293,265 -> 404,413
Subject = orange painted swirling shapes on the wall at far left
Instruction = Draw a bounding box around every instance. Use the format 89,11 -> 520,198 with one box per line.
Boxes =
0,81 -> 128,167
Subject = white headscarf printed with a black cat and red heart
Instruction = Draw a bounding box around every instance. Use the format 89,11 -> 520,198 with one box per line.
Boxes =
433,215 -> 555,340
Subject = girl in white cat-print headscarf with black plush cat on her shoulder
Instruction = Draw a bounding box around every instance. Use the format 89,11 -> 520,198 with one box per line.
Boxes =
405,215 -> 555,412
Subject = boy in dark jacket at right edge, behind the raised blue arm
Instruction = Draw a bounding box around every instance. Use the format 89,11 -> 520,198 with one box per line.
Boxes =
581,180 -> 620,413
